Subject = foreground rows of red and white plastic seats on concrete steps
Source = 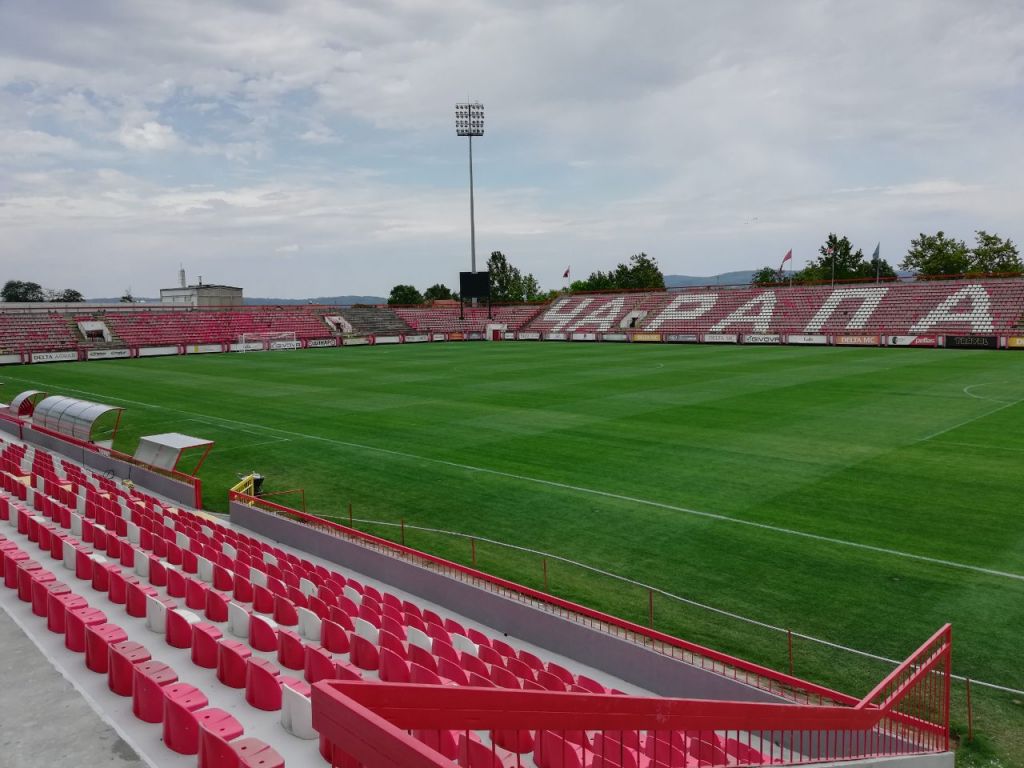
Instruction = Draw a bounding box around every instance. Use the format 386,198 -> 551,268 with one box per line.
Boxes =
0,442 -> 770,768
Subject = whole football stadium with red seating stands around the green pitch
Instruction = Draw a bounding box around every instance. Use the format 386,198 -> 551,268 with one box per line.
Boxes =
0,279 -> 1024,768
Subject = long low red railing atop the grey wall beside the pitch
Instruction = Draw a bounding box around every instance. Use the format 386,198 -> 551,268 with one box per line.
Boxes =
228,492 -> 858,707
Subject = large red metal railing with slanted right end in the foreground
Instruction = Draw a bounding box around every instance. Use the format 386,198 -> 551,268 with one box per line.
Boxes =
312,625 -> 952,768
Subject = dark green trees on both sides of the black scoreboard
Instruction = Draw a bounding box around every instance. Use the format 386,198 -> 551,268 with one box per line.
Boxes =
387,251 -> 665,305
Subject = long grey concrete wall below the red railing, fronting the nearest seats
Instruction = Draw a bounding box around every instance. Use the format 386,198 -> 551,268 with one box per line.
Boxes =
230,502 -> 782,701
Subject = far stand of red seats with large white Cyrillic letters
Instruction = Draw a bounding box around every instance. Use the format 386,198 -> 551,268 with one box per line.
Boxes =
524,280 -> 1024,335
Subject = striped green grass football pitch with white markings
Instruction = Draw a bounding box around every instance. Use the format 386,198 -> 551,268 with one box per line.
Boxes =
0,343 -> 1024,764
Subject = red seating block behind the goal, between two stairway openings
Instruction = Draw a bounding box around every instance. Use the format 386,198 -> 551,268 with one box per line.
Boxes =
104,307 -> 331,346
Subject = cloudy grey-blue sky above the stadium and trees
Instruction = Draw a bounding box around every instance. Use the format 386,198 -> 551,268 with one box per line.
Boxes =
0,0 -> 1024,297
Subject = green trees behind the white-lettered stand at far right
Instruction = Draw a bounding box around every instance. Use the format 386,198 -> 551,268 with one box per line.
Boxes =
751,229 -> 1024,284
